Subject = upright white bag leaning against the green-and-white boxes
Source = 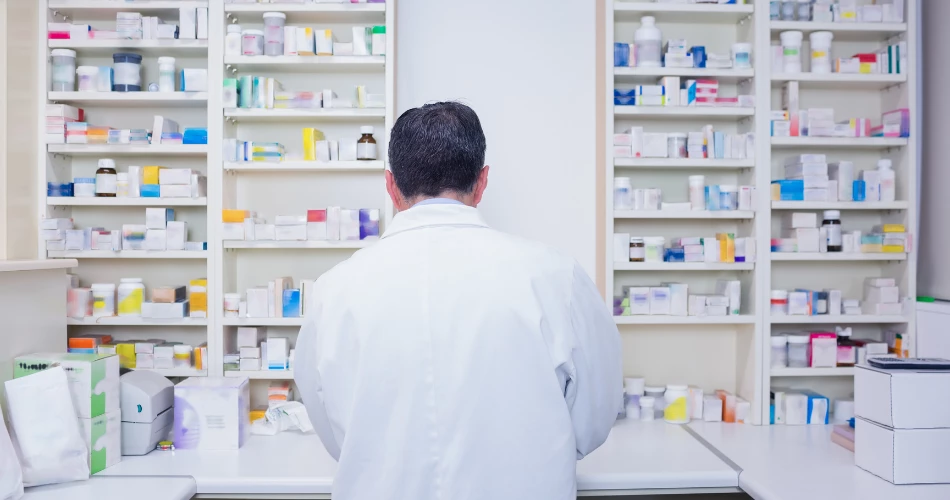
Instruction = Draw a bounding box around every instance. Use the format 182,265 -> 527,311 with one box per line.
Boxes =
4,366 -> 89,486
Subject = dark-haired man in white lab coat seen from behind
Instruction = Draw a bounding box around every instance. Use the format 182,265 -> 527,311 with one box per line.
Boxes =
294,102 -> 623,500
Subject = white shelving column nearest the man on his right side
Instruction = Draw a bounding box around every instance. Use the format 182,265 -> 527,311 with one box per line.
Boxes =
603,0 -> 768,420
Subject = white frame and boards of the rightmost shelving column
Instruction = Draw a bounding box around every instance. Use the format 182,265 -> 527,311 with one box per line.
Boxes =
755,0 -> 920,415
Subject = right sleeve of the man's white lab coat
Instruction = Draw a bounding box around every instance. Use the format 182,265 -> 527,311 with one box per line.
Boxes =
565,264 -> 623,460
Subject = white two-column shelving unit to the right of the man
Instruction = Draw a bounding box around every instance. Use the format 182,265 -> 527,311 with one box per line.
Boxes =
603,0 -> 919,424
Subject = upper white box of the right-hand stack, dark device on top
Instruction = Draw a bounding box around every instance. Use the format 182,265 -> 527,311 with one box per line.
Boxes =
854,366 -> 950,430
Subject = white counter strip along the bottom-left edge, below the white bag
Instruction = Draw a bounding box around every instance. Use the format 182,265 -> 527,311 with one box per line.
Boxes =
22,476 -> 196,500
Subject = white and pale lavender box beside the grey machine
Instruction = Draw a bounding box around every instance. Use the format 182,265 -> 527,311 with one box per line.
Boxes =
173,377 -> 250,450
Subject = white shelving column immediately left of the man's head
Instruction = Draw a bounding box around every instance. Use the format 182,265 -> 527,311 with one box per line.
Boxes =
215,0 -> 395,399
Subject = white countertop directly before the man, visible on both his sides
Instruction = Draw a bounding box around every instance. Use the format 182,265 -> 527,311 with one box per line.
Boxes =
106,421 -> 739,500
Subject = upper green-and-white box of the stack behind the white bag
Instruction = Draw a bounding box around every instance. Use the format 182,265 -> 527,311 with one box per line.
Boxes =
13,352 -> 119,418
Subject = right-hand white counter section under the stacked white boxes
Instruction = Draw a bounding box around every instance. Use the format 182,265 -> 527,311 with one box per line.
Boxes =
689,422 -> 950,500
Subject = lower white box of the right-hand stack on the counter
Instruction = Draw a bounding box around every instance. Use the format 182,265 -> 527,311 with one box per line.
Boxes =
854,418 -> 950,484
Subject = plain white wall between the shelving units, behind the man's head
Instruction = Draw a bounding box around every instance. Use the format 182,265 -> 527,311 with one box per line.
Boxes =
396,0 -> 597,277
